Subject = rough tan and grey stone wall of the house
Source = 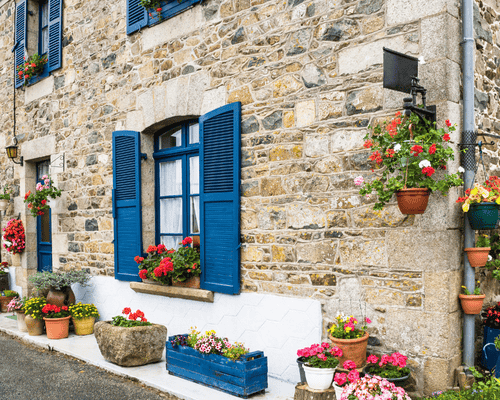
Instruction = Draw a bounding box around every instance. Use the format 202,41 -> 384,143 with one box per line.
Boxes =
0,0 -> 500,394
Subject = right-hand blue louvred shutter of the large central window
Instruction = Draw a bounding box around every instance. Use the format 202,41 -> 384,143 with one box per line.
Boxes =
200,102 -> 241,294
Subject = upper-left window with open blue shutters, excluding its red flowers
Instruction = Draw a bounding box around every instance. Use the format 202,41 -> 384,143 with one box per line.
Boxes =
14,0 -> 62,88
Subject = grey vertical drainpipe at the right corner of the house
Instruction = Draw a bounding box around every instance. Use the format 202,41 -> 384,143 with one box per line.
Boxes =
461,0 -> 477,367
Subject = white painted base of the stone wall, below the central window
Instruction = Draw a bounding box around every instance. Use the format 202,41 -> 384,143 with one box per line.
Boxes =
73,276 -> 321,383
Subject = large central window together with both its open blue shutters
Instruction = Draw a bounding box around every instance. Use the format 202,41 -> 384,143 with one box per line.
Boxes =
113,103 -> 241,294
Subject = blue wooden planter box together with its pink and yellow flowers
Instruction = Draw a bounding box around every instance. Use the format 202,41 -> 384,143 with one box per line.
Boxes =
167,329 -> 267,398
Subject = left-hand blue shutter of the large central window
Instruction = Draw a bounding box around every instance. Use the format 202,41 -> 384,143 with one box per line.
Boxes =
113,131 -> 142,282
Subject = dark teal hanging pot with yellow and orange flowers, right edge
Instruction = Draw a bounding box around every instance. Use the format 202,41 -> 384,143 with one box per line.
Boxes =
457,176 -> 500,230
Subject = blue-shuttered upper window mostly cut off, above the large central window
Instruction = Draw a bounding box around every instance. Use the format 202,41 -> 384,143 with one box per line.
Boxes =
127,0 -> 203,35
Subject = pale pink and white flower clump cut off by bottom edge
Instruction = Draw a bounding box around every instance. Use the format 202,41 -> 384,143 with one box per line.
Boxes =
339,376 -> 411,400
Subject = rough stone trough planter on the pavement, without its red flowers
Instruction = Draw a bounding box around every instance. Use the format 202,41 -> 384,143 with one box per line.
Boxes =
94,321 -> 167,367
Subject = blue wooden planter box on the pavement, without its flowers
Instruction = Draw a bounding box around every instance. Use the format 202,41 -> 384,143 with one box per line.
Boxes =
167,335 -> 267,398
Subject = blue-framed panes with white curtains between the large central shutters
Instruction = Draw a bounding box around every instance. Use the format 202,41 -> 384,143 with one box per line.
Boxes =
154,121 -> 200,249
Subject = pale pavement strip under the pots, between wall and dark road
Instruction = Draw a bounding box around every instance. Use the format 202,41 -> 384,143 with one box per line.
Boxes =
0,313 -> 295,400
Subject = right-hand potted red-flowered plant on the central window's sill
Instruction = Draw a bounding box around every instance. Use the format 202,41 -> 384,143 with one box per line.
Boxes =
171,236 -> 201,289
